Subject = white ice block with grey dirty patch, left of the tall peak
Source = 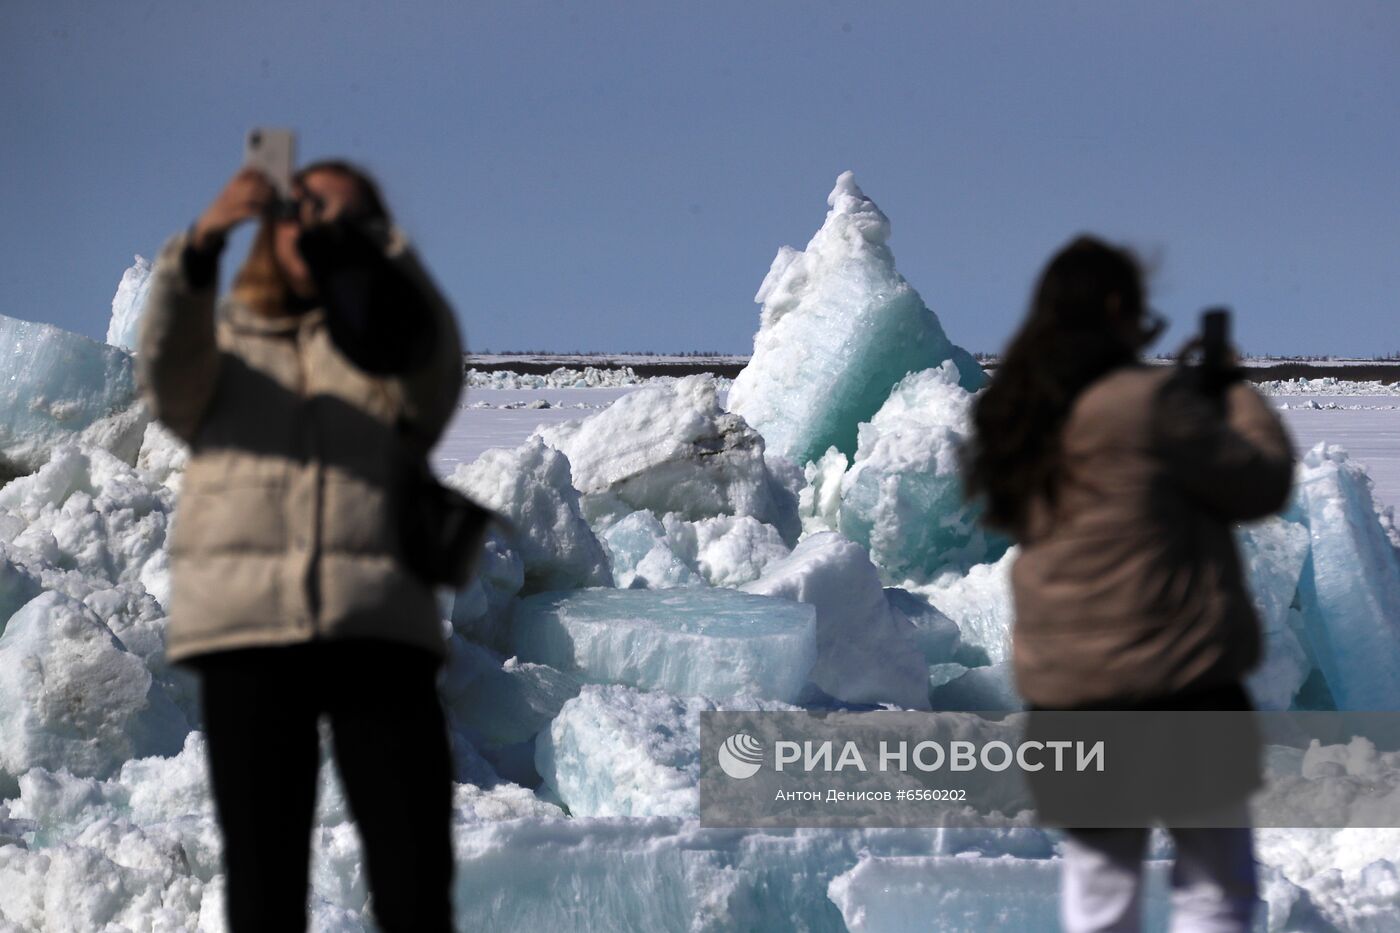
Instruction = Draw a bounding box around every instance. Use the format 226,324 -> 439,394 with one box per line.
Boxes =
539,375 -> 798,538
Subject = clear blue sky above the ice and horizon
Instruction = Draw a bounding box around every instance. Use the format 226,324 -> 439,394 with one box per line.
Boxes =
0,0 -> 1400,354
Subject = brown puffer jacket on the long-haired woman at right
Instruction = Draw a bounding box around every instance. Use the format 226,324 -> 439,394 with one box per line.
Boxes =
1011,366 -> 1294,709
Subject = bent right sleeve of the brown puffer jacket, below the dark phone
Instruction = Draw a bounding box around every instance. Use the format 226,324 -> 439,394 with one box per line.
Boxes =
1154,380 -> 1294,521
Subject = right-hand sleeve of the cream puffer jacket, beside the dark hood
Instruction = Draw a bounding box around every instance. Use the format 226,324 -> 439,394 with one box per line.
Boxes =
386,230 -> 463,450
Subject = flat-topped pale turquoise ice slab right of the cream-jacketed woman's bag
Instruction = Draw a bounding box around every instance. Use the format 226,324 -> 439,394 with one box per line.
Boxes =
514,587 -> 816,702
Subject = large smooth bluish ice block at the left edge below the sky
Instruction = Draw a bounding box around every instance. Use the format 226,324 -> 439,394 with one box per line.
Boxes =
0,315 -> 150,479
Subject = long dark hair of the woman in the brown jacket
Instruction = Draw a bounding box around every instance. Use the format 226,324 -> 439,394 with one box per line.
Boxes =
963,235 -> 1145,538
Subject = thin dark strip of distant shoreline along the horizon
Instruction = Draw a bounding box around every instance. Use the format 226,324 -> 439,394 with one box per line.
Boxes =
466,353 -> 1400,385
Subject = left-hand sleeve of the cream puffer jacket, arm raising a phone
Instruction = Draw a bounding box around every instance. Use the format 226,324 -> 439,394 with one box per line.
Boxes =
136,234 -> 220,443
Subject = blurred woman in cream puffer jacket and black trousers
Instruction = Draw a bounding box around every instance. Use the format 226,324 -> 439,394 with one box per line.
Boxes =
137,154 -> 462,933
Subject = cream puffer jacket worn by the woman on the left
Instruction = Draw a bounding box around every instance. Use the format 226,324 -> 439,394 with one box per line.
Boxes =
137,225 -> 462,661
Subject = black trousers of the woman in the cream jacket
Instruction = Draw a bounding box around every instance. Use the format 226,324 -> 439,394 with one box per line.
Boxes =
192,640 -> 452,933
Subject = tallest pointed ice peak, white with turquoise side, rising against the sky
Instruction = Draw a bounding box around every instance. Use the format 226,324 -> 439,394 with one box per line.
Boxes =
728,172 -> 986,464
